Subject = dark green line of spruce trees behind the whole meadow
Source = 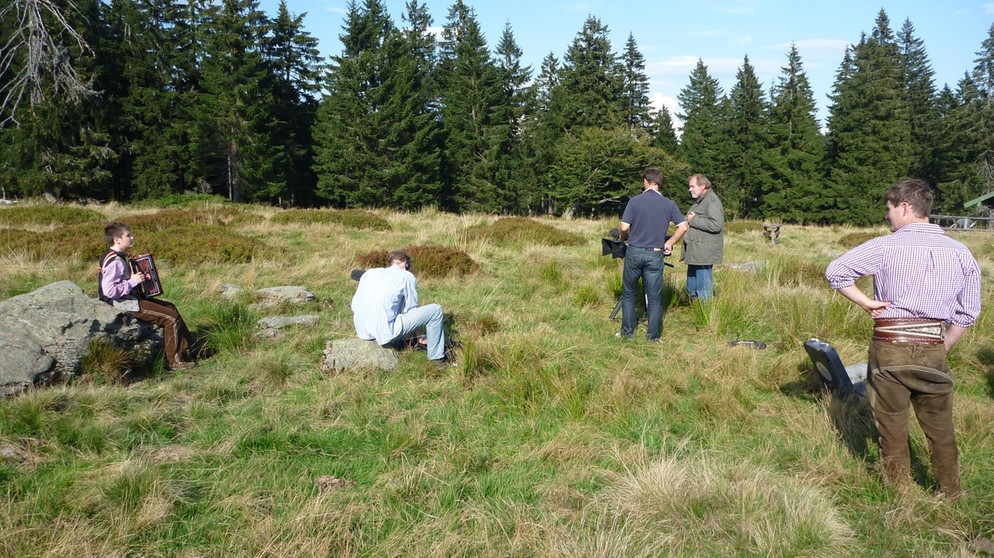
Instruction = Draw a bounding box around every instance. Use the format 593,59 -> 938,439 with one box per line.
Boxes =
0,0 -> 994,225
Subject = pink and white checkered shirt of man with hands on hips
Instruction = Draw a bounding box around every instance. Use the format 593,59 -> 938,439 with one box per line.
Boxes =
825,223 -> 980,327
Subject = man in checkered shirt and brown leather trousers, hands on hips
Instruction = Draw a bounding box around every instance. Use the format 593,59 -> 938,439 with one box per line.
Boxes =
825,180 -> 980,497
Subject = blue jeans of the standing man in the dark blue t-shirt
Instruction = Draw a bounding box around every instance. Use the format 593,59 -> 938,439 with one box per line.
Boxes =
621,246 -> 663,341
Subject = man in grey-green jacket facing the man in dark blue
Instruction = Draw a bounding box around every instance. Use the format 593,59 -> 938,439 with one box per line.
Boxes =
681,174 -> 725,300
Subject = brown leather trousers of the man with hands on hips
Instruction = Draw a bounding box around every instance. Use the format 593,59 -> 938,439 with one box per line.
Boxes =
867,341 -> 960,496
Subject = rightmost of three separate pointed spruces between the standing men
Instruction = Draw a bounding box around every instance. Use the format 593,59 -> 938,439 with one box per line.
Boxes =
760,44 -> 832,223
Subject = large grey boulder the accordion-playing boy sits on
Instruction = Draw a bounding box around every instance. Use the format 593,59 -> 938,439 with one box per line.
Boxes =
0,281 -> 162,395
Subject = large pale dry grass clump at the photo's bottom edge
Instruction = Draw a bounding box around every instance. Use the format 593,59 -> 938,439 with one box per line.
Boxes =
548,457 -> 854,557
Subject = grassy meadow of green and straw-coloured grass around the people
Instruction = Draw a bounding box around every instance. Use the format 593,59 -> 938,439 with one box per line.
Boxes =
0,198 -> 994,558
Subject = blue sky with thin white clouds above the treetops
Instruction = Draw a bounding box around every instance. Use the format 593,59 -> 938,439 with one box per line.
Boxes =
260,0 -> 994,124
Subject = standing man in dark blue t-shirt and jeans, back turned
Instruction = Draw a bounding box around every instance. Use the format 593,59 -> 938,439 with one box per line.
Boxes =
618,168 -> 688,343
